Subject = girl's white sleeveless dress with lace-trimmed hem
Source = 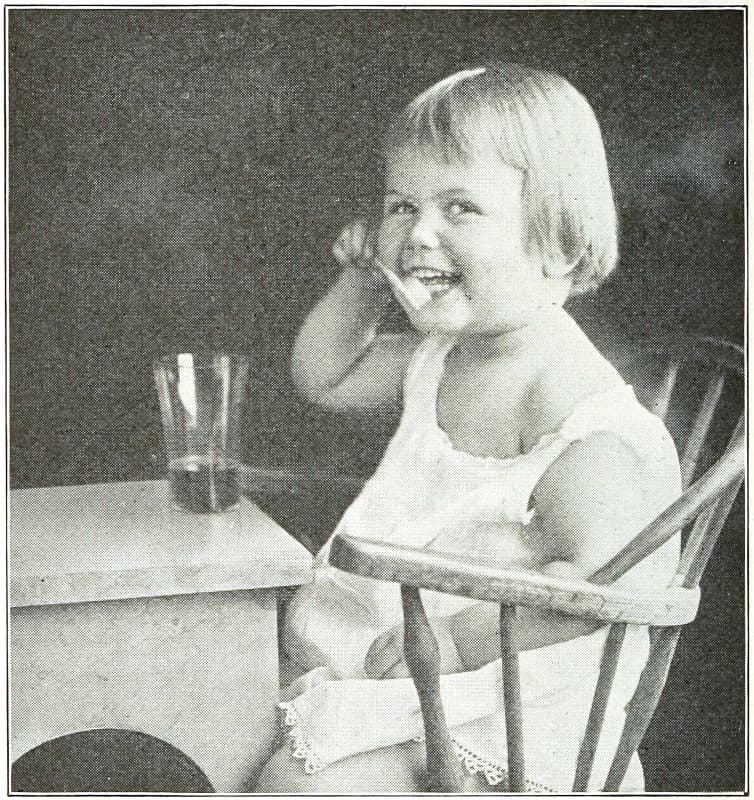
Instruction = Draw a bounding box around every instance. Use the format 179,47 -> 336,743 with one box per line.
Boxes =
281,336 -> 681,793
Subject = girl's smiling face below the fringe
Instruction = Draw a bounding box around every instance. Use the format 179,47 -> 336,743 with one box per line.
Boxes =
378,149 -> 546,335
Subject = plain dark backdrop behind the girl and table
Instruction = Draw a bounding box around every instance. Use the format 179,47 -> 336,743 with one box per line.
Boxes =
8,9 -> 744,791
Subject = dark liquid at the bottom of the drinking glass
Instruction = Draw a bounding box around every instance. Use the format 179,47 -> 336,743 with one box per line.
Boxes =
168,457 -> 240,513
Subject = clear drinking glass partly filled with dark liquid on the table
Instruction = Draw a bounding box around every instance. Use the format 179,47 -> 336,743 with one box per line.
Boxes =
153,353 -> 249,513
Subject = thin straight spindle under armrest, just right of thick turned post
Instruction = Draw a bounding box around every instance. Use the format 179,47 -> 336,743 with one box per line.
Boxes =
500,605 -> 525,793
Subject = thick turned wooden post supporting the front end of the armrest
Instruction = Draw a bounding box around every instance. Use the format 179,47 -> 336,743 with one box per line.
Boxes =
401,585 -> 462,793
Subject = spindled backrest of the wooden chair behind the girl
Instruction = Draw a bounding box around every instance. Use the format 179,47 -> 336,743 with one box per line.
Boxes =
573,332 -> 745,792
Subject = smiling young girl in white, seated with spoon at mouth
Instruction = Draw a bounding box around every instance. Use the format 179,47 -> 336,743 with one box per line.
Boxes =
257,64 -> 680,794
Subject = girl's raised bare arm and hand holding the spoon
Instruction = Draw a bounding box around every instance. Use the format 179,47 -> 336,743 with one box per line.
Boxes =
291,222 -> 418,409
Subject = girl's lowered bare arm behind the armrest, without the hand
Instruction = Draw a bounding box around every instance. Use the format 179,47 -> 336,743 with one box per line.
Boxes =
448,434 -> 673,669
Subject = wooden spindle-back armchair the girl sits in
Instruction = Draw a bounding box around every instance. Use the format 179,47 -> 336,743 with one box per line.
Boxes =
330,335 -> 746,792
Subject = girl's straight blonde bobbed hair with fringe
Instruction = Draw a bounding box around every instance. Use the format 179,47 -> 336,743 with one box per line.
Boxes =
385,63 -> 618,292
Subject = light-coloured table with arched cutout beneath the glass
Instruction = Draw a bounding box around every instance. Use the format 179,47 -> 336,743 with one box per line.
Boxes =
9,481 -> 312,792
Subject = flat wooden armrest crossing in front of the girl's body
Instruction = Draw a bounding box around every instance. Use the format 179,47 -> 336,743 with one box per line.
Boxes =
330,535 -> 699,626
